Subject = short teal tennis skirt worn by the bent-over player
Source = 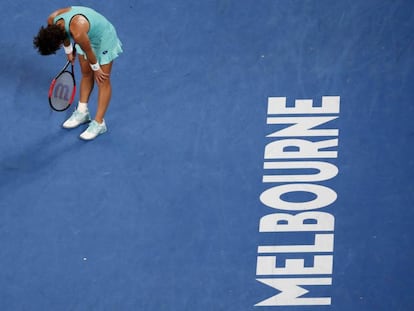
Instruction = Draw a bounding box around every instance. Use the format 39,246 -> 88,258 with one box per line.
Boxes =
76,25 -> 122,65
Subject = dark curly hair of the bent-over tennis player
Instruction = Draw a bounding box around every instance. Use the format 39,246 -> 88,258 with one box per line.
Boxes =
33,24 -> 67,55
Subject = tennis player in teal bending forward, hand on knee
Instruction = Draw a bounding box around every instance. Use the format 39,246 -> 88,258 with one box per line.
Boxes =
33,6 -> 122,140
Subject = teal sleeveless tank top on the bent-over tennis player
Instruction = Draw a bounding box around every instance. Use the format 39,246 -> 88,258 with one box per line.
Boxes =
53,6 -> 113,45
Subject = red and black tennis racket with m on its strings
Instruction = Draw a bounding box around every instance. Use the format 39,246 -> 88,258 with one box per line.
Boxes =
49,48 -> 76,111
